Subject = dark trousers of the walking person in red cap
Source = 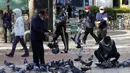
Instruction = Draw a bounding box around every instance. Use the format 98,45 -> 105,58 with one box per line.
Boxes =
83,28 -> 98,42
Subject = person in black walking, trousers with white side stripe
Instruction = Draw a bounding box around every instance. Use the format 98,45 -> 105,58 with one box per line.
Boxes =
53,14 -> 69,53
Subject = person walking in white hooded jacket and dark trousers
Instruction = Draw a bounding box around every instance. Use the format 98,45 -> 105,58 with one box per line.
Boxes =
6,8 -> 29,57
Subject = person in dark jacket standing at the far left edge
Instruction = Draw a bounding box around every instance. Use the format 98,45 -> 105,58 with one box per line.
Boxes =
2,9 -> 12,43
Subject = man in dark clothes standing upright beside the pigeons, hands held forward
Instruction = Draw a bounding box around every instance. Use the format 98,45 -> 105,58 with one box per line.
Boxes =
31,10 -> 49,66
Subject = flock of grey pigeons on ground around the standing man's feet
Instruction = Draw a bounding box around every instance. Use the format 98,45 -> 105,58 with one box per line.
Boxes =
0,56 -> 93,73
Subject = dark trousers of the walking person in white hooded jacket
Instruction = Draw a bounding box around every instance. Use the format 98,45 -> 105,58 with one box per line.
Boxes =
11,36 -> 29,54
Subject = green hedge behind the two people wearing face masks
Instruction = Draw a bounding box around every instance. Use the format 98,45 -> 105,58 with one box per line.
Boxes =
91,6 -> 130,20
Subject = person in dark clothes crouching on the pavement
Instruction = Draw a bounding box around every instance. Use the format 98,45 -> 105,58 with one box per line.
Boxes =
94,36 -> 120,65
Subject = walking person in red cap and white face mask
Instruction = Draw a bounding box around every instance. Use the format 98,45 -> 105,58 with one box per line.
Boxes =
82,6 -> 99,44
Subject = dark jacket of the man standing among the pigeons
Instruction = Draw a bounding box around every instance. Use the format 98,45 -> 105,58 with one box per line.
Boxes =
31,15 -> 48,41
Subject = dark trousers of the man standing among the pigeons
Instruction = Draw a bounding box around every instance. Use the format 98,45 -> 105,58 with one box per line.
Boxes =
31,40 -> 45,66
